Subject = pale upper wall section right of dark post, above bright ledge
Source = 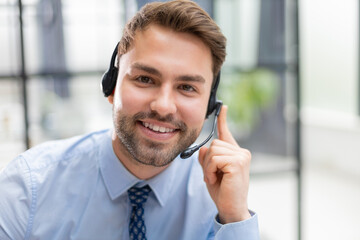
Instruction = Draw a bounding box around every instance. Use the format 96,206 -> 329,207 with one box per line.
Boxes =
300,0 -> 358,114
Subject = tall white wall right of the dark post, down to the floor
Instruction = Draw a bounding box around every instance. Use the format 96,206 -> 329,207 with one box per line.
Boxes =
300,0 -> 360,175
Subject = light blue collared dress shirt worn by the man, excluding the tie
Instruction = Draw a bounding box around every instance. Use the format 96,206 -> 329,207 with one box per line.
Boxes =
0,130 -> 259,240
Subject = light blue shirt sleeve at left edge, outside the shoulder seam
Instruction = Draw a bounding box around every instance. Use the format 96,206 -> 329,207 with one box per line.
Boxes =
0,156 -> 34,239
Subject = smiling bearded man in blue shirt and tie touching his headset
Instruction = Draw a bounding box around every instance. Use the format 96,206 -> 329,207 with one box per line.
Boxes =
0,0 -> 259,240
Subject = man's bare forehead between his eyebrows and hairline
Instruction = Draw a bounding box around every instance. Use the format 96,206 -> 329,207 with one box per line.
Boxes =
121,24 -> 213,81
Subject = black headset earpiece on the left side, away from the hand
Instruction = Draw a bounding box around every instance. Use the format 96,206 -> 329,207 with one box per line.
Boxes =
101,43 -> 119,97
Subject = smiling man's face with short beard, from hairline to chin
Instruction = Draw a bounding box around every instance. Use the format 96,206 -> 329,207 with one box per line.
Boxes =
109,25 -> 213,167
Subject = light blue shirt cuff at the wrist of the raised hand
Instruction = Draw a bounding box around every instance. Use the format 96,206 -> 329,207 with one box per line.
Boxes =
214,211 -> 260,240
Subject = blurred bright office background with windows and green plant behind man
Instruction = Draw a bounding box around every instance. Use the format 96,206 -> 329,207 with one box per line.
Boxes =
0,0 -> 360,240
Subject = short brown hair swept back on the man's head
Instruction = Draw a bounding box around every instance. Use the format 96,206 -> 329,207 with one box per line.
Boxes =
118,0 -> 226,76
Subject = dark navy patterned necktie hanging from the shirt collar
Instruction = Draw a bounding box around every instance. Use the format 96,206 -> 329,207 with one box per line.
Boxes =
128,185 -> 151,240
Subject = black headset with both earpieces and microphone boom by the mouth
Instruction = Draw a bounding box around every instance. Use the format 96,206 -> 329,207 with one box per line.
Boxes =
101,43 -> 222,159
